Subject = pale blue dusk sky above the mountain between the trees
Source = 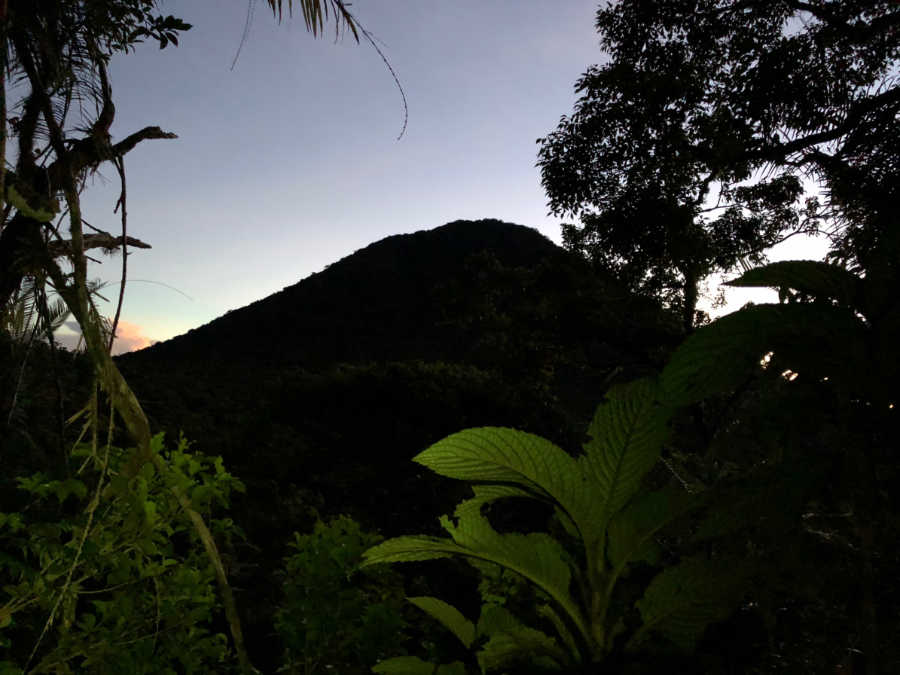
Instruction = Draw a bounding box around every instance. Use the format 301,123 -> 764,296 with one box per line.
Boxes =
59,0 -> 828,352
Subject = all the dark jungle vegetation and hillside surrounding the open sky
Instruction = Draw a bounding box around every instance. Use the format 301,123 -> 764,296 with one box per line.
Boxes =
0,0 -> 900,675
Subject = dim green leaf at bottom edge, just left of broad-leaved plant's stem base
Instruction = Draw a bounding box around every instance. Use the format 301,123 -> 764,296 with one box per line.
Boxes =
478,605 -> 568,672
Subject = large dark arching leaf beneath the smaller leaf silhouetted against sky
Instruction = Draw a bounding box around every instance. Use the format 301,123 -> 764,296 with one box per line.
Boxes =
661,303 -> 866,406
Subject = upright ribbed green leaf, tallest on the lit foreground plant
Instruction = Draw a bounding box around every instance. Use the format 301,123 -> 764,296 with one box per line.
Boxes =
579,380 -> 669,546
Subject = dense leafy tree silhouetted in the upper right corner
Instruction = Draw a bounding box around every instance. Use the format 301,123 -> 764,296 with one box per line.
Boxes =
538,0 -> 900,329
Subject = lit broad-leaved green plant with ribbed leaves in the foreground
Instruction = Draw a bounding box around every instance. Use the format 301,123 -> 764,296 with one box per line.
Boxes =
363,380 -> 746,674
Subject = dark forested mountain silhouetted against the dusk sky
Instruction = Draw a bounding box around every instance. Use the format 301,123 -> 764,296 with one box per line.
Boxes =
118,220 -> 677,536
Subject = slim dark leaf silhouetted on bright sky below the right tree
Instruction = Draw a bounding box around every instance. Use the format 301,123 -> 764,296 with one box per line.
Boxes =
726,260 -> 862,306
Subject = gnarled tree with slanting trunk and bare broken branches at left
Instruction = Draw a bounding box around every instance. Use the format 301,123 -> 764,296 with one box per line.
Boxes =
0,0 -> 372,672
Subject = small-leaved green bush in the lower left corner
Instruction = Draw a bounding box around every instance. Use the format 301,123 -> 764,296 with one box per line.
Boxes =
0,435 -> 243,675
